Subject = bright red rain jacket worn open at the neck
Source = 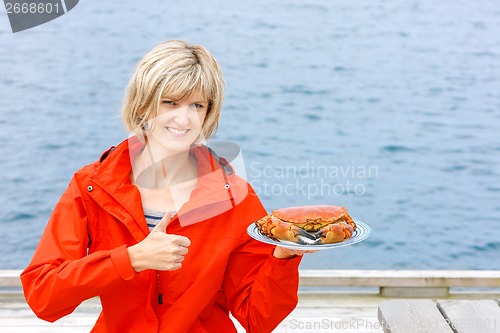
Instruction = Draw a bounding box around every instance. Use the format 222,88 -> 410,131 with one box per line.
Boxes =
21,136 -> 301,333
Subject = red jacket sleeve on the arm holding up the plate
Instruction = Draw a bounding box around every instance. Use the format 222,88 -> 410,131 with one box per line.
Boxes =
223,189 -> 302,333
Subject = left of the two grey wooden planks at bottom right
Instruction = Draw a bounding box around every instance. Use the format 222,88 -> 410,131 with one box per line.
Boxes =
378,299 -> 453,333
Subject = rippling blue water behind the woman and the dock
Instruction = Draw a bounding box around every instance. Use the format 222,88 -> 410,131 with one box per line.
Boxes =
0,0 -> 500,269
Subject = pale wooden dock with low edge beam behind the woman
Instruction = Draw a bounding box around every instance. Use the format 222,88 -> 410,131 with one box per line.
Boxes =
0,270 -> 500,333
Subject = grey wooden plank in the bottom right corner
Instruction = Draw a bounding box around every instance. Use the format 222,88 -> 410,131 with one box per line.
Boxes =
437,300 -> 500,333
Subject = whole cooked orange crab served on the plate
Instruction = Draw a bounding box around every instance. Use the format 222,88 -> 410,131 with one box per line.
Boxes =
255,205 -> 356,245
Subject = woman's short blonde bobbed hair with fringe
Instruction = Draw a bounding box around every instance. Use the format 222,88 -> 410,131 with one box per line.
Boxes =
122,40 -> 225,138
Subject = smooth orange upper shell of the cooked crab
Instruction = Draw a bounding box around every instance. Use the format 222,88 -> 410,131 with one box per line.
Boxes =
272,205 -> 356,231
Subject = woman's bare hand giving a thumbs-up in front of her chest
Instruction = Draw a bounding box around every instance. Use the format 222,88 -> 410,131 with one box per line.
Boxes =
127,213 -> 191,272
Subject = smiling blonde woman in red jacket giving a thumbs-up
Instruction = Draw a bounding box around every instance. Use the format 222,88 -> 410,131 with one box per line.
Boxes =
21,41 -> 310,333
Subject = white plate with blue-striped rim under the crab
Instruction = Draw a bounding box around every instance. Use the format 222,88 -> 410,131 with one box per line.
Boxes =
247,220 -> 371,251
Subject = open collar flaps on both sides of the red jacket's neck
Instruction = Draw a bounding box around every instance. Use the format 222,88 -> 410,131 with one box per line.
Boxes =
90,137 -> 248,240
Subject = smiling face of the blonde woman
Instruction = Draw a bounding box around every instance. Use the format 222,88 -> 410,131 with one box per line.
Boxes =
148,90 -> 208,153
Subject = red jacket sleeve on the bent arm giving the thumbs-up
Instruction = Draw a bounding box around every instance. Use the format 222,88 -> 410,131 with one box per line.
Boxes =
21,177 -> 135,322
